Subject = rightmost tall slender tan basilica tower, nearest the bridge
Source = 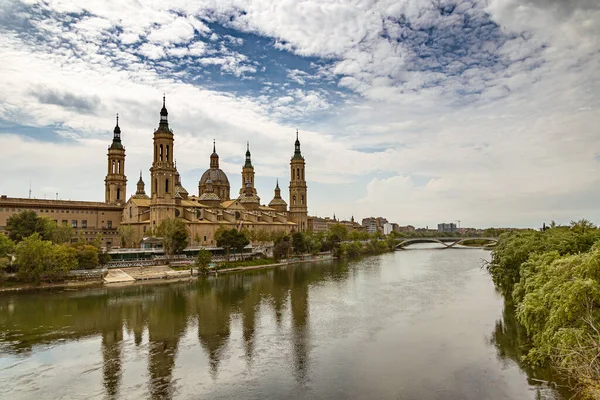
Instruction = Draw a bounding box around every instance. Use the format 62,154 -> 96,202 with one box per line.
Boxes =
289,130 -> 308,232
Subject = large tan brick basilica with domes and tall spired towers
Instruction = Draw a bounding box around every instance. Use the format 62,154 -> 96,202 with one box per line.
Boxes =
111,97 -> 308,246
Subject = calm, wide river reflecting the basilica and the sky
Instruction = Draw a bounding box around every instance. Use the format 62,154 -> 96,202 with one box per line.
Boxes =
0,249 -> 568,400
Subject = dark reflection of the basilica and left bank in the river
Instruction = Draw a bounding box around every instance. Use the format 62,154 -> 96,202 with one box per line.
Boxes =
0,264 -> 345,399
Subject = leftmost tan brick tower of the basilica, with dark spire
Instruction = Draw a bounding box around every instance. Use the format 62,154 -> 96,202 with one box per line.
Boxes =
104,114 -> 127,205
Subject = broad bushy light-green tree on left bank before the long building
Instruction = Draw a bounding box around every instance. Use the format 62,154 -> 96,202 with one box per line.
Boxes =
15,233 -> 77,282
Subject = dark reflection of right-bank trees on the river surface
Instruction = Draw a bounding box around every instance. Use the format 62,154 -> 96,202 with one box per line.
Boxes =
490,301 -> 573,399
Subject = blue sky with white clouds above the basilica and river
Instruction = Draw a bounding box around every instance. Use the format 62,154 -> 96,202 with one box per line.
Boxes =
0,0 -> 600,228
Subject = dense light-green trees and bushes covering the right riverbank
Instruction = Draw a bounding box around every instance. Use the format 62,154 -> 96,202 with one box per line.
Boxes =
487,220 -> 600,398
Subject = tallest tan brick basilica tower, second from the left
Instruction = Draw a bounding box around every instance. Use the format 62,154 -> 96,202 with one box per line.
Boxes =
150,96 -> 177,228
